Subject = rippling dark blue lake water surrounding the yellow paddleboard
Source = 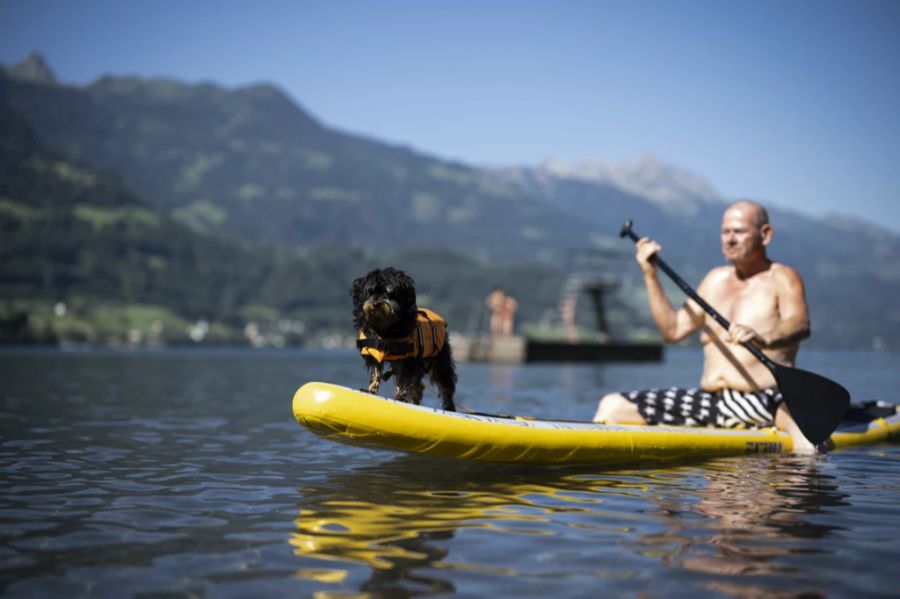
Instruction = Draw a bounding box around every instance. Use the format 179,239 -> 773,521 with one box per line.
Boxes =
0,349 -> 900,598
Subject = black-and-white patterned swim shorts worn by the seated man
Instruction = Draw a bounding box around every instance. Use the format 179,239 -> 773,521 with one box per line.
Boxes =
622,387 -> 782,428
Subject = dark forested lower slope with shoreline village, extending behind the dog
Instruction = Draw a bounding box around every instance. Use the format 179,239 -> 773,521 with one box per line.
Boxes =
0,105 -> 561,344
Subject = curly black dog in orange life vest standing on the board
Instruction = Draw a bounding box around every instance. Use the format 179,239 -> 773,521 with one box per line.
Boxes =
350,267 -> 456,411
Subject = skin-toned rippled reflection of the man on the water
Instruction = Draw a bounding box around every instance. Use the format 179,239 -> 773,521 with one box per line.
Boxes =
642,457 -> 847,597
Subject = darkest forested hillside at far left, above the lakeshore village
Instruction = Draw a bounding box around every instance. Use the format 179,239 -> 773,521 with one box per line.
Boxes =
0,107 -> 292,340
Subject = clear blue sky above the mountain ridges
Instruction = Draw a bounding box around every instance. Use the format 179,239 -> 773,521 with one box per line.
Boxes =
0,0 -> 900,232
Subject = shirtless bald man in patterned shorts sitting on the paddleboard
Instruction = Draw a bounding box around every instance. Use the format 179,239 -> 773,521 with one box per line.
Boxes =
594,200 -> 815,453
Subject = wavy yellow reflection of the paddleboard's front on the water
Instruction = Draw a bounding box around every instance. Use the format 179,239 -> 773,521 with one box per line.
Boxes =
290,458 -> 653,582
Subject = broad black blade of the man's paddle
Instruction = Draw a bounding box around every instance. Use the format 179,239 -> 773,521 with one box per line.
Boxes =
773,364 -> 850,445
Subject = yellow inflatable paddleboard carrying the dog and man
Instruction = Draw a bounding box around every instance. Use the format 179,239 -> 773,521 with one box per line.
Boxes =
293,382 -> 900,464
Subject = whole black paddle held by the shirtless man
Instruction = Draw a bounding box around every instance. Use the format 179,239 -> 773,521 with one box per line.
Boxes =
619,220 -> 850,445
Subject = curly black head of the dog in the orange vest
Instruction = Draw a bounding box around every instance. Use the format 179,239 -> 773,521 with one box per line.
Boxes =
350,267 -> 417,337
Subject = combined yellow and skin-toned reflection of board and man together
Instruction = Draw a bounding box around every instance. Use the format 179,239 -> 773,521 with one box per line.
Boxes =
290,457 -> 846,596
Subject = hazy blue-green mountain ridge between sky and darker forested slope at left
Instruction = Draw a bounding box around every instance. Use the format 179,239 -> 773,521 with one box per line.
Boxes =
0,62 -> 608,262
